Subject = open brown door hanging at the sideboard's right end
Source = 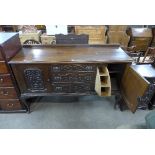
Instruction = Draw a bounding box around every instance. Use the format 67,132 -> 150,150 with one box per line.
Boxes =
121,66 -> 150,113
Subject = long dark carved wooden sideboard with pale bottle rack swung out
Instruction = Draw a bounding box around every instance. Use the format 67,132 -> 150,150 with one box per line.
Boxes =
9,45 -> 132,110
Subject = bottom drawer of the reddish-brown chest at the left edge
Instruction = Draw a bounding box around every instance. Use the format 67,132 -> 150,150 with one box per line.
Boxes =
0,99 -> 22,111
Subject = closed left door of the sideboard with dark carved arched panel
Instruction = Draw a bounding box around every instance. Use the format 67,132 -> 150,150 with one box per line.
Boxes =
12,64 -> 51,93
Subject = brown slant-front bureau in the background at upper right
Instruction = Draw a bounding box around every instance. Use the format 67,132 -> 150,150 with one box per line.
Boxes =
128,28 -> 152,53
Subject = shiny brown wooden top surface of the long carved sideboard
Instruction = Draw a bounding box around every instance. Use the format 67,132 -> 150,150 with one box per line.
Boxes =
9,46 -> 132,64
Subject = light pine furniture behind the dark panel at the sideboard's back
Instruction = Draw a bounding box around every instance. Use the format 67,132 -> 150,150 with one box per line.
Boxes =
75,25 -> 107,44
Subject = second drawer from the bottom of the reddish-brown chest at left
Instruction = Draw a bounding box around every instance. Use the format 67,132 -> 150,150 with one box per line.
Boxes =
0,87 -> 17,99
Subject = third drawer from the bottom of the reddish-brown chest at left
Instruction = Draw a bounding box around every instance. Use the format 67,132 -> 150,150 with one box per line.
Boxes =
0,74 -> 13,87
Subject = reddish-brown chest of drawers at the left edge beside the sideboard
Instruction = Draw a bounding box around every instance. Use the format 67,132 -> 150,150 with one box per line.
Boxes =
0,32 -> 26,112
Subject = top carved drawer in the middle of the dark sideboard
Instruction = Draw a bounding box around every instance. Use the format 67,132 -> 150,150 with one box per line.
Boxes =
51,64 -> 96,72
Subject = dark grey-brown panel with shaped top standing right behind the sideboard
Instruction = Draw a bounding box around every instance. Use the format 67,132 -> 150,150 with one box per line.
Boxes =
55,34 -> 89,44
